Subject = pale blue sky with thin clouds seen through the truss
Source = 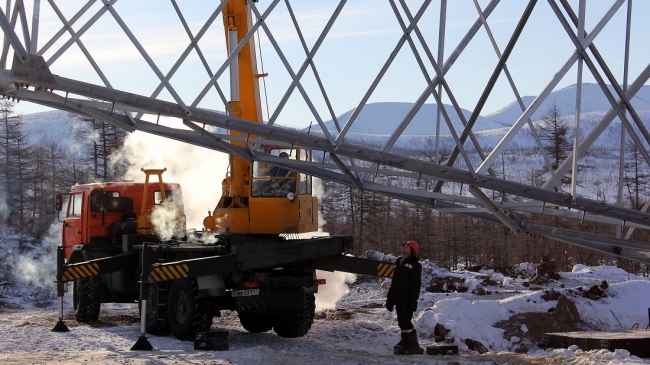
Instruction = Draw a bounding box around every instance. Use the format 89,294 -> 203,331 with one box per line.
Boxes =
8,0 -> 650,127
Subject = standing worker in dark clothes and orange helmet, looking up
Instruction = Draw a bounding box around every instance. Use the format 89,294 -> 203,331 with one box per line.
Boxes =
386,241 -> 424,355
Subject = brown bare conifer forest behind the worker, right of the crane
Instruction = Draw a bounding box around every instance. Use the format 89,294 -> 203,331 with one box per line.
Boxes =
321,182 -> 650,275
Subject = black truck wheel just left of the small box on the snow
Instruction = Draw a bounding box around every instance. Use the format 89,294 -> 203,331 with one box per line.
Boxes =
167,279 -> 212,341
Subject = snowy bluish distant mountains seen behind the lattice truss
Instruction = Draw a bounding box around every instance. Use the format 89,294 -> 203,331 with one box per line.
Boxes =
17,84 -> 650,148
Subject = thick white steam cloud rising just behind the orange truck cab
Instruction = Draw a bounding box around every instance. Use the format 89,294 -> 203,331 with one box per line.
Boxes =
111,117 -> 228,230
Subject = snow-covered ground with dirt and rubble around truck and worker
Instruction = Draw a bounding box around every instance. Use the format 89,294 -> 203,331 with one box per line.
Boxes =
0,249 -> 650,364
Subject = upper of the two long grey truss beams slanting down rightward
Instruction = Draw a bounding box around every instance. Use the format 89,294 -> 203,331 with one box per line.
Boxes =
5,70 -> 650,229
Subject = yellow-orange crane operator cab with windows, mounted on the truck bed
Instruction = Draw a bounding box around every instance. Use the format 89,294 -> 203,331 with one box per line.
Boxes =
203,146 -> 318,234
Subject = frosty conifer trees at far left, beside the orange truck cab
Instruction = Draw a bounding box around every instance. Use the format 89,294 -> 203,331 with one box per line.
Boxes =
0,99 -> 126,239
